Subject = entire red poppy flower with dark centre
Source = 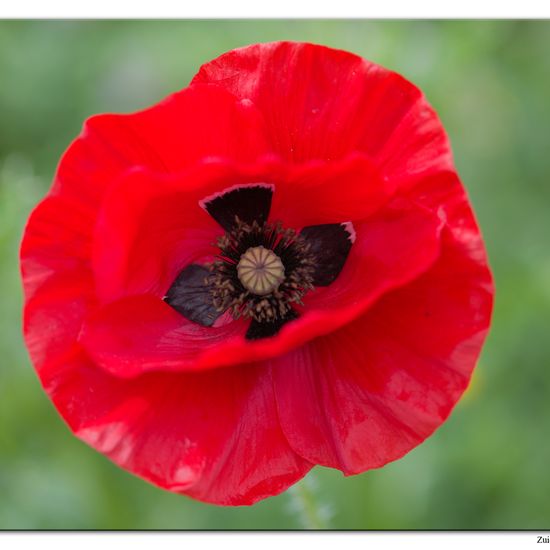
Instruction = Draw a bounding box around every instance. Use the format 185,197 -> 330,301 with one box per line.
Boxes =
21,43 -> 493,504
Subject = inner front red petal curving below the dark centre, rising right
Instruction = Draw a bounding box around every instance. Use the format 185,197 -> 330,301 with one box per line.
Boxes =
80,199 -> 442,377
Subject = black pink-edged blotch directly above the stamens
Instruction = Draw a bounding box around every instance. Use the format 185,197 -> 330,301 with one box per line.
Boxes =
200,184 -> 274,231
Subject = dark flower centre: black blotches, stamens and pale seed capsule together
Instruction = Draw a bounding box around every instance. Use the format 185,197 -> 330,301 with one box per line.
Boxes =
164,183 -> 355,340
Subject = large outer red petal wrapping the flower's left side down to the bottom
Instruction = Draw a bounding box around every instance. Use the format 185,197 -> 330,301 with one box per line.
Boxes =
21,87 -> 311,504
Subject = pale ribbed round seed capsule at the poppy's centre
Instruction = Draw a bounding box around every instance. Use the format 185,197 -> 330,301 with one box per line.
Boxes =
237,246 -> 285,296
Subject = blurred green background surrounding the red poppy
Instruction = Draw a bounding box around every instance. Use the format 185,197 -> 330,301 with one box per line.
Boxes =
0,20 -> 550,529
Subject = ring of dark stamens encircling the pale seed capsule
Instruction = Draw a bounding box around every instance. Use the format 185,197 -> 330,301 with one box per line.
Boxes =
206,217 -> 315,322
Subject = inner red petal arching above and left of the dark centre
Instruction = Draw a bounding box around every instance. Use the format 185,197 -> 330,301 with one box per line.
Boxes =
92,155 -> 392,301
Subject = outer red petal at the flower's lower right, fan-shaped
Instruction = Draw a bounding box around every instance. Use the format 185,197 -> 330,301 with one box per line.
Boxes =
272,232 -> 492,474
